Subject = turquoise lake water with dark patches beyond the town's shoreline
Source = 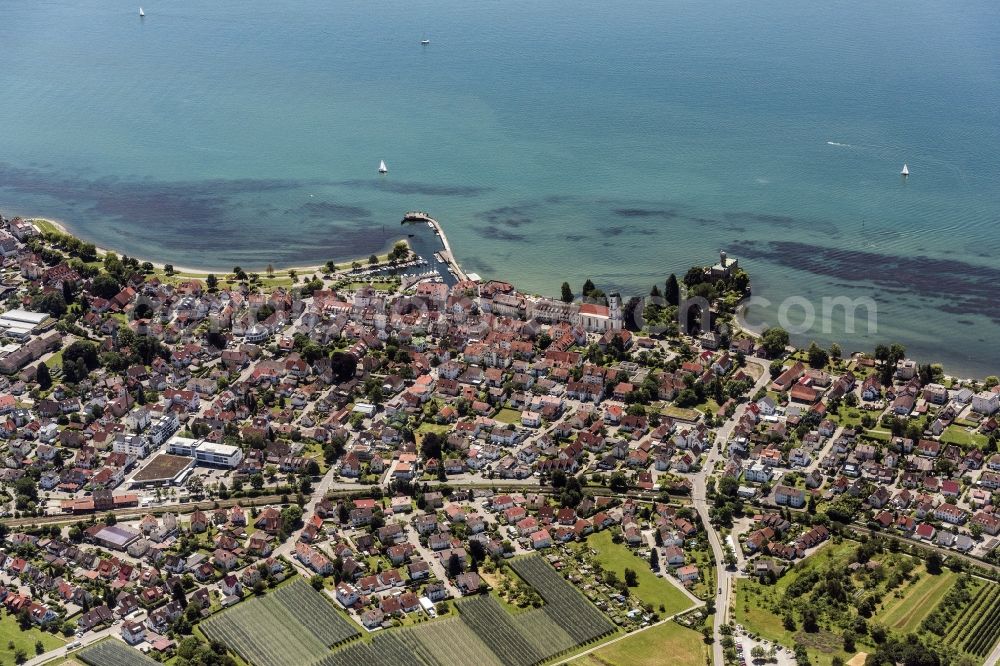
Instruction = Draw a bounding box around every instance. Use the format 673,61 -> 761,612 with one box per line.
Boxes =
0,0 -> 1000,375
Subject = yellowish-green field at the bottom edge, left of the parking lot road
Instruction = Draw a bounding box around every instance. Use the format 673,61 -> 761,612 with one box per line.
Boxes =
570,622 -> 708,666
